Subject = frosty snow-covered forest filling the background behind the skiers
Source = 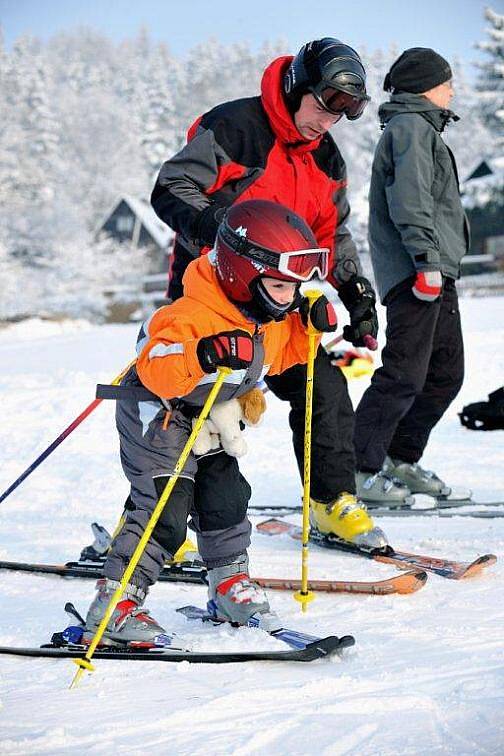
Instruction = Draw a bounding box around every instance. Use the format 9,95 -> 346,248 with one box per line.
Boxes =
0,25 -> 502,318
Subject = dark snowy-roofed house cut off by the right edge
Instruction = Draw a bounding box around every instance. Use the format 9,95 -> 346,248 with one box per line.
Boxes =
461,155 -> 504,260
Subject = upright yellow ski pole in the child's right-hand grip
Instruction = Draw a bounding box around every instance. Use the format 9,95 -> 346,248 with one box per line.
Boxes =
294,289 -> 322,612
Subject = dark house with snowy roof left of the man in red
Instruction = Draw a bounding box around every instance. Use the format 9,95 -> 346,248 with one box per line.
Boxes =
95,194 -> 174,273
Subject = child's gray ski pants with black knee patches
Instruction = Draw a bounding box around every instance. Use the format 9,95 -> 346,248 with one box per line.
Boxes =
104,400 -> 251,589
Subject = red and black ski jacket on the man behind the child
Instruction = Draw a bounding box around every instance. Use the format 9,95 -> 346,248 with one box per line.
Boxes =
151,57 -> 360,298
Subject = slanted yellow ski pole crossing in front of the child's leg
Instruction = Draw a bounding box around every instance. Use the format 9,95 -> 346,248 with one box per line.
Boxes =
70,367 -> 232,688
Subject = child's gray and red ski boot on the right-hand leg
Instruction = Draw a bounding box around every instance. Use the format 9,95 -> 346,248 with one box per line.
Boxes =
208,554 -> 282,632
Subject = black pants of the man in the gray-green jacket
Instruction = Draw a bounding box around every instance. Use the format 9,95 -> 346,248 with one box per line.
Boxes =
354,278 -> 464,472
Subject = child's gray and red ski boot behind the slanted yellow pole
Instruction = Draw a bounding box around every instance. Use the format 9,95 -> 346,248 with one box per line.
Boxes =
83,578 -> 166,646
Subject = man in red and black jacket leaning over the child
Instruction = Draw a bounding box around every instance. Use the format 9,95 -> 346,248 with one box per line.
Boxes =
151,38 -> 382,545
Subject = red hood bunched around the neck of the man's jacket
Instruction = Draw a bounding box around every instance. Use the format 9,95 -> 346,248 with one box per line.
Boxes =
261,55 -> 322,152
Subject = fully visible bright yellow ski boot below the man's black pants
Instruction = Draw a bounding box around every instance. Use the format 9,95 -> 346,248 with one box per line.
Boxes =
310,491 -> 387,549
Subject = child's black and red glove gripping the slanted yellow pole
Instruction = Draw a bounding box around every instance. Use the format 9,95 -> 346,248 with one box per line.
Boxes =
196,330 -> 254,373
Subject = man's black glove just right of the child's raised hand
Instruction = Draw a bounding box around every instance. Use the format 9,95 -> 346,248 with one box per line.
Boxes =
338,276 -> 378,350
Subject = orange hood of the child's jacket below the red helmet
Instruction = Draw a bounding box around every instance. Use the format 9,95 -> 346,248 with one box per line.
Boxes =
182,251 -> 261,333
